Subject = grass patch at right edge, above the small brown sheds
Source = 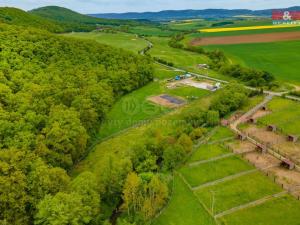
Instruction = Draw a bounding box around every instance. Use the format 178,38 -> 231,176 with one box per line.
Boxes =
258,98 -> 300,135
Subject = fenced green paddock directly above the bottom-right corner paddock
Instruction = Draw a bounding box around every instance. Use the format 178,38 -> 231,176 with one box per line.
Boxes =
196,172 -> 281,214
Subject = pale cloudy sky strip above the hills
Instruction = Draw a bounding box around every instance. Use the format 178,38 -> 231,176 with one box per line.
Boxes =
0,0 -> 300,14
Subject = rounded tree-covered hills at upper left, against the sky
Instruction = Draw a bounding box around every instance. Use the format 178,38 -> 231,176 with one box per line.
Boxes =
0,6 -> 148,33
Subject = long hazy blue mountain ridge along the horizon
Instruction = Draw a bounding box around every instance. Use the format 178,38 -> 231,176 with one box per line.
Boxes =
89,6 -> 300,20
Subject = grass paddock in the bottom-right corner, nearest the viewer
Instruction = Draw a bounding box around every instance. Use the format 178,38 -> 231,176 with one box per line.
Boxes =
220,196 -> 300,225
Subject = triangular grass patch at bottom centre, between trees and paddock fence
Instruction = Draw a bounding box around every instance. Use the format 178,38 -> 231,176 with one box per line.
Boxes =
152,175 -> 216,225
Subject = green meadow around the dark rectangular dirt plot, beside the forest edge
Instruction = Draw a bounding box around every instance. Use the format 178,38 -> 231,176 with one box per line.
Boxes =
99,66 -> 210,139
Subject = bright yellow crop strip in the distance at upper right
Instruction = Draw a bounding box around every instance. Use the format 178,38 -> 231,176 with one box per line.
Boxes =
199,25 -> 300,33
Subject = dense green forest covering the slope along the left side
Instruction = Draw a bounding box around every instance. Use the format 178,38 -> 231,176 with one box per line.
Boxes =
0,24 -> 153,224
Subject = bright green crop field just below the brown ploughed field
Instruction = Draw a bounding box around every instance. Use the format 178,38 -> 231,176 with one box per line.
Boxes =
205,41 -> 300,84
